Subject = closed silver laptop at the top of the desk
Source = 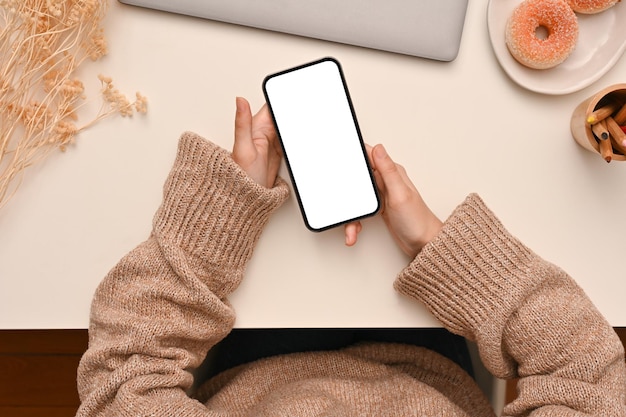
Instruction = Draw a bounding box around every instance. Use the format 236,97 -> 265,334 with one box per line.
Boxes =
119,0 -> 468,61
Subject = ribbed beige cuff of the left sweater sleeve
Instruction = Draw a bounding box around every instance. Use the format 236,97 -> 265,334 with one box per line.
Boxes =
153,132 -> 289,295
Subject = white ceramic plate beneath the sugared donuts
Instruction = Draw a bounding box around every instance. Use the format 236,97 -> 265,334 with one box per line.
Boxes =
487,0 -> 626,94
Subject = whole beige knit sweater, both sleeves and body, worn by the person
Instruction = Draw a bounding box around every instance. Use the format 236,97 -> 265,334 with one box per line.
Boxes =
78,133 -> 626,417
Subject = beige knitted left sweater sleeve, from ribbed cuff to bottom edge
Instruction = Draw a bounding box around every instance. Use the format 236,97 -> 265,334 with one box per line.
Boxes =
78,133 -> 288,417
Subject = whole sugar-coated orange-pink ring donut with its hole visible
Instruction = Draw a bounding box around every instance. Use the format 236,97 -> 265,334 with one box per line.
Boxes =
505,0 -> 578,69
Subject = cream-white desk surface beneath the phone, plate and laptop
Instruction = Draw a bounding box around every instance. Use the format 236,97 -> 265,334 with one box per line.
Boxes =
0,1 -> 626,329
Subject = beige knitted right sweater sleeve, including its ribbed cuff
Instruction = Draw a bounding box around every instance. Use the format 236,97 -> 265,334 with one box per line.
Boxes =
395,195 -> 626,416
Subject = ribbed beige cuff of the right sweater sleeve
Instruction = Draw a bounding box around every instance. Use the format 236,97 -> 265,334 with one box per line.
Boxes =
395,194 -> 545,340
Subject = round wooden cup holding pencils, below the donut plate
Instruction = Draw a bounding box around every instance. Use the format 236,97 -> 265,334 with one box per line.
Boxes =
570,84 -> 626,161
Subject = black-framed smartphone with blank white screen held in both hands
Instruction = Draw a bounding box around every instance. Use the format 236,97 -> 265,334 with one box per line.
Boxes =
263,58 -> 380,232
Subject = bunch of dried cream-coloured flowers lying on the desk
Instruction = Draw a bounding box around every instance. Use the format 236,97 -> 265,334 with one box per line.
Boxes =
0,0 -> 147,208
